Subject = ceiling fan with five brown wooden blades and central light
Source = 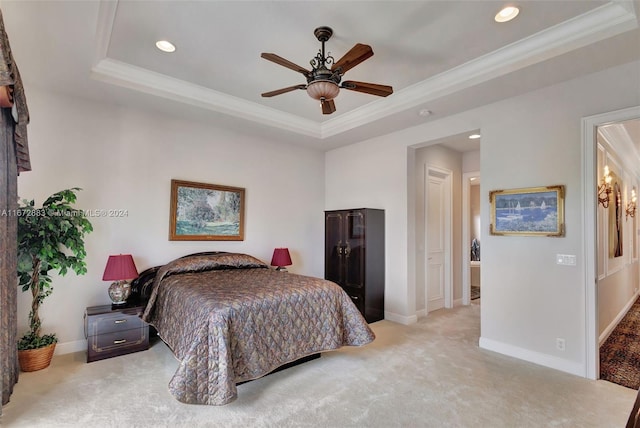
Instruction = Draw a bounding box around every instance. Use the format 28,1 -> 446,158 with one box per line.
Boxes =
260,27 -> 393,114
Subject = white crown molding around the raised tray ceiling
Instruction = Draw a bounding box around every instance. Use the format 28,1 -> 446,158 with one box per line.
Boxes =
91,0 -> 639,139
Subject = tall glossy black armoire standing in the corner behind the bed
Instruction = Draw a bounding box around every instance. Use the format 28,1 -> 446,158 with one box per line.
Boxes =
324,208 -> 384,323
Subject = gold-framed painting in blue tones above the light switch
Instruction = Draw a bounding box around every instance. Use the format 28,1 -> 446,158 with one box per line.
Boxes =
489,185 -> 564,236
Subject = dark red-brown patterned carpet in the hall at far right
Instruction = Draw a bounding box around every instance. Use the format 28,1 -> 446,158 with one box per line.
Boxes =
600,298 -> 640,390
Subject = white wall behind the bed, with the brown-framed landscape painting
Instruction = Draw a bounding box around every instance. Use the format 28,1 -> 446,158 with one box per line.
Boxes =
18,87 -> 324,353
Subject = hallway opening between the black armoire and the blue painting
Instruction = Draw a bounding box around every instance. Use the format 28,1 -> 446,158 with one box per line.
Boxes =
416,129 -> 480,317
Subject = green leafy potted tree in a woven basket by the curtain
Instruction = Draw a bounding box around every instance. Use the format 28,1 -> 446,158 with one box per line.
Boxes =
17,187 -> 93,371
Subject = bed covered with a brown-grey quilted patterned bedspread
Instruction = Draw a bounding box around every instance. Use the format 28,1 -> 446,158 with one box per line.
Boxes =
132,253 -> 375,405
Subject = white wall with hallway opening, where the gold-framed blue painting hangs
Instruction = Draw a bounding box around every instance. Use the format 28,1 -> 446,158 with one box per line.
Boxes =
325,62 -> 640,374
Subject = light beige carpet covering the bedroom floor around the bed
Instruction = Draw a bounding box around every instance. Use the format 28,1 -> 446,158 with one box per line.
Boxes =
0,305 -> 636,428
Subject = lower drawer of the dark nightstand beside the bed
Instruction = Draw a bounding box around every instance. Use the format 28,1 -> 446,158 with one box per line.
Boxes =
87,323 -> 149,362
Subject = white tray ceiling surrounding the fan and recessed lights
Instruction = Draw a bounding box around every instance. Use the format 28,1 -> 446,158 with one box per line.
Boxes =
0,0 -> 640,150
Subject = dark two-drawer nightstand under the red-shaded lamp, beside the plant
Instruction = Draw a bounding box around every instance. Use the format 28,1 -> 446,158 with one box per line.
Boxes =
84,303 -> 149,363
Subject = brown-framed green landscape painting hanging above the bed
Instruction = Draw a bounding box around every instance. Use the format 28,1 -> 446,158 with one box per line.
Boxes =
169,180 -> 244,241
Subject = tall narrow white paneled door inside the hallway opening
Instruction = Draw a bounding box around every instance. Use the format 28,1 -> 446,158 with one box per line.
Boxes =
425,167 -> 452,313
